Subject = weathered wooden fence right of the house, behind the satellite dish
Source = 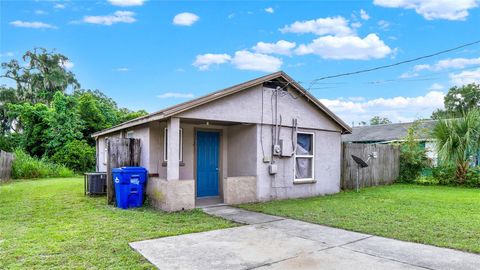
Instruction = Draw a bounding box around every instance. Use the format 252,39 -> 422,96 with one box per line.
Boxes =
342,143 -> 400,189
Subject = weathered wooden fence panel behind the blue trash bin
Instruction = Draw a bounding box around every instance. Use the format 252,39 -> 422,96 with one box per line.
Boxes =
107,138 -> 140,204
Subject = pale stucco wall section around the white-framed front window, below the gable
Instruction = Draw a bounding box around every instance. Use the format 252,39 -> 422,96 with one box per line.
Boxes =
257,125 -> 341,201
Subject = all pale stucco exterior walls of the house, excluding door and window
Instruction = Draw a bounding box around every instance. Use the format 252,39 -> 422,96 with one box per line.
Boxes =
97,83 -> 341,210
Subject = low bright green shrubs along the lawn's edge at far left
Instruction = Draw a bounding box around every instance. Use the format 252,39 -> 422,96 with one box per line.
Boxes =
12,149 -> 74,179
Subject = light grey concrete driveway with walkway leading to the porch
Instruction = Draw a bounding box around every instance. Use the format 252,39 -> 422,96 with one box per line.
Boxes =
130,206 -> 480,270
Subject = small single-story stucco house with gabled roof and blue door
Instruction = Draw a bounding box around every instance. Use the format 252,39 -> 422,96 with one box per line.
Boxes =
93,72 -> 351,211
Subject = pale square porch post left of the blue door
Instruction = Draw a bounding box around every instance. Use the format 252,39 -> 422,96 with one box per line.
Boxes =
167,117 -> 180,181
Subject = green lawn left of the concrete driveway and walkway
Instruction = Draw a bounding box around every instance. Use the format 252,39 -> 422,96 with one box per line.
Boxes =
0,177 -> 235,269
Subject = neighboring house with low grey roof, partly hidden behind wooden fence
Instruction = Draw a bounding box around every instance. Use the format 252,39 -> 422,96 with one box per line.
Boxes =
342,120 -> 437,165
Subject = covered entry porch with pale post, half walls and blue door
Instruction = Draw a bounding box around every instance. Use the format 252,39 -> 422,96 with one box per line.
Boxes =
147,117 -> 257,211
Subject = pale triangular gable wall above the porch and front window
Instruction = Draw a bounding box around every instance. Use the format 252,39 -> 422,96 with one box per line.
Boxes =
178,85 -> 341,131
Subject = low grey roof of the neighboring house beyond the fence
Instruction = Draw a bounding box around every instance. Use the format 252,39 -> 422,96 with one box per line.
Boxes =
342,120 -> 437,142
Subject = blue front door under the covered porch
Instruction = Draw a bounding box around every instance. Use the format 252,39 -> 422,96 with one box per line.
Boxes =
197,131 -> 220,197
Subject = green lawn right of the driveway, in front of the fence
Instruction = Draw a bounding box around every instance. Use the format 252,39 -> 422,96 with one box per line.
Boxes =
241,184 -> 480,253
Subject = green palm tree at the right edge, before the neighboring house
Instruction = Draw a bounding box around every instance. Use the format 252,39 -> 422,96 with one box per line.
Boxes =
434,109 -> 480,183
